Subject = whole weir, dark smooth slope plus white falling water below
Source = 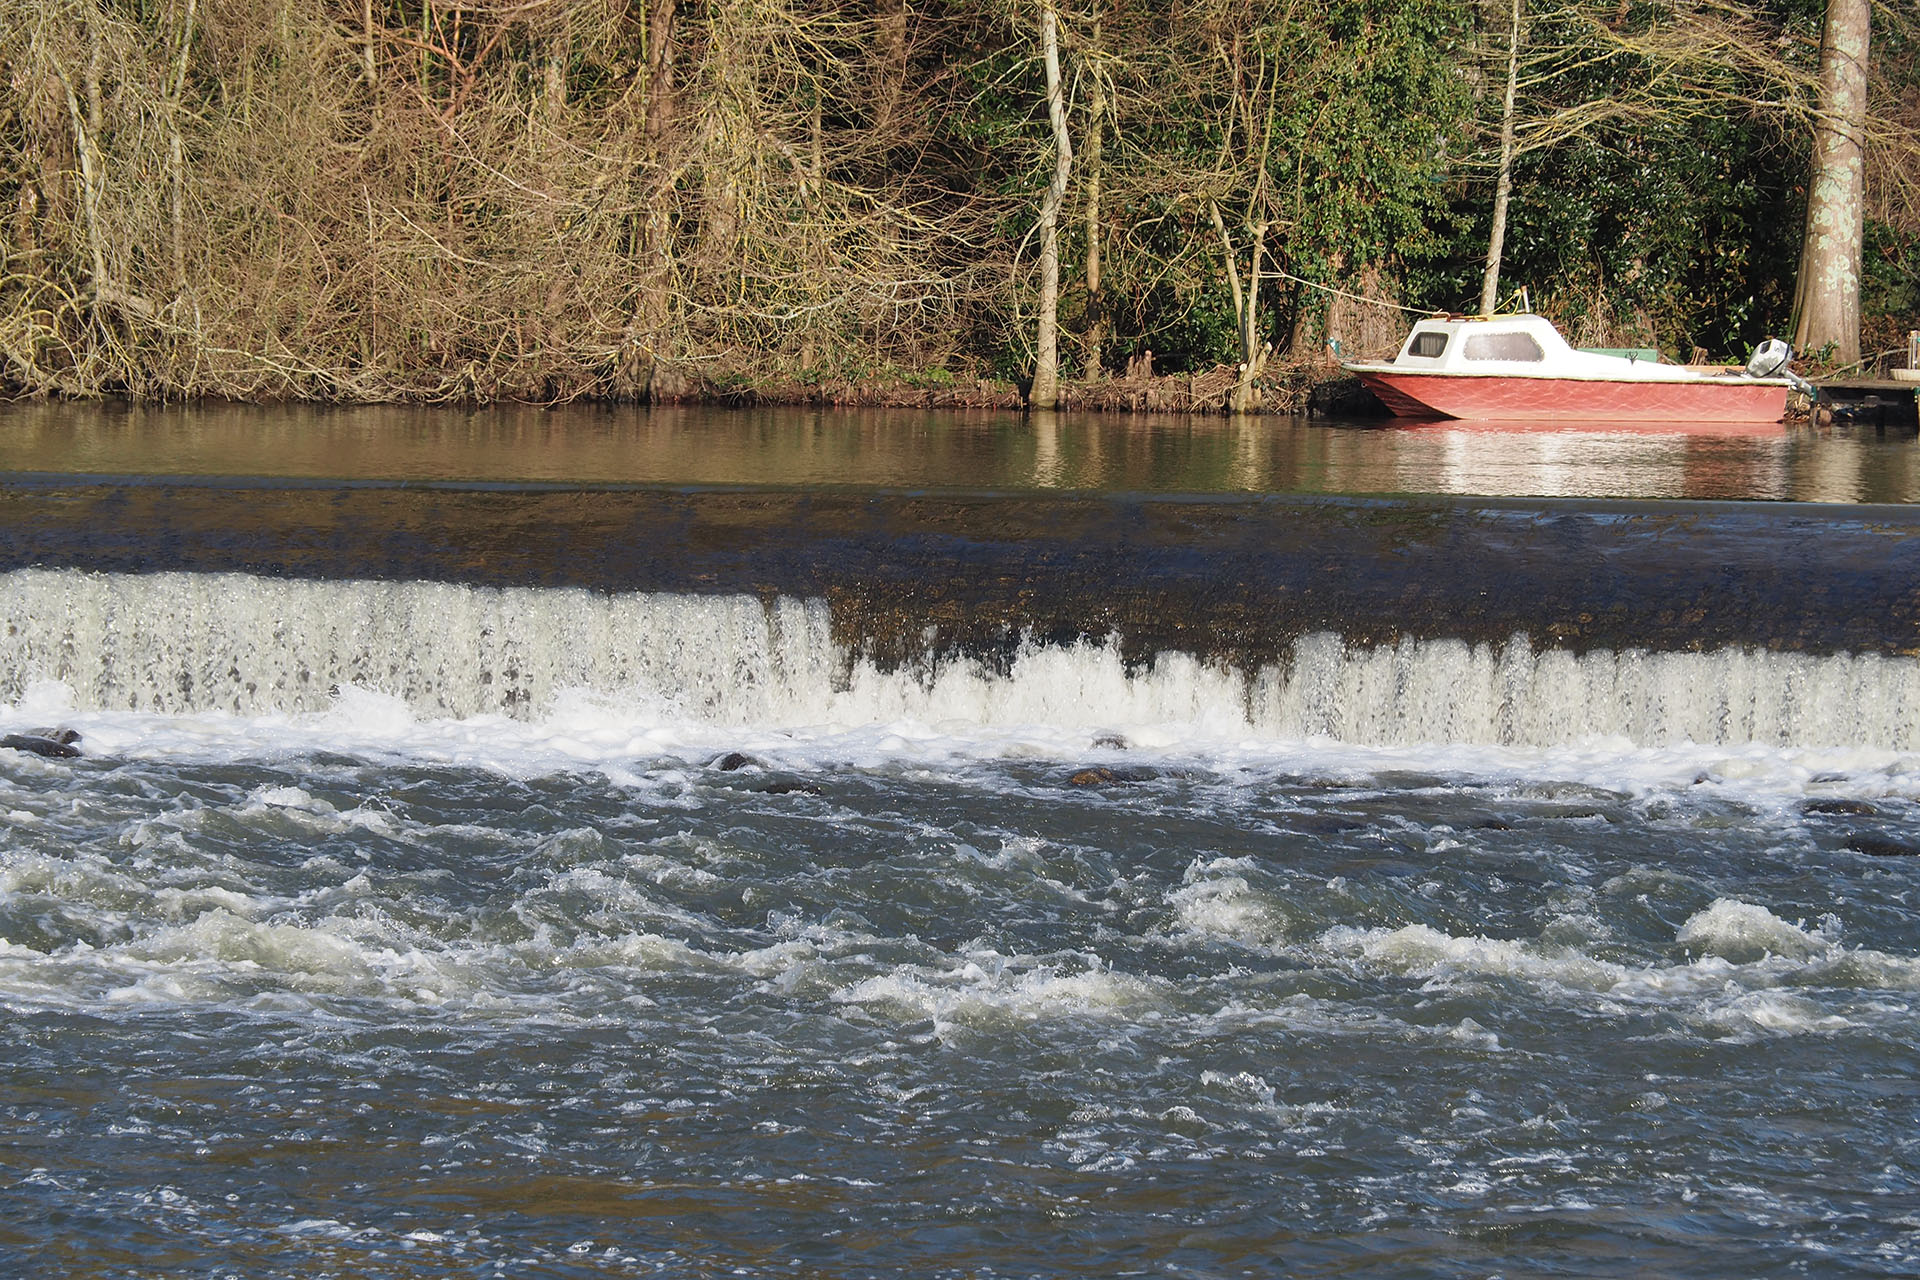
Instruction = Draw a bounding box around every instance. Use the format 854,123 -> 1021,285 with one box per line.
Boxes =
0,476 -> 1920,748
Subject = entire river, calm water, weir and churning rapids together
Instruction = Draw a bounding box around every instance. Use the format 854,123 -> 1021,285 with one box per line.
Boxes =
0,407 -> 1920,1278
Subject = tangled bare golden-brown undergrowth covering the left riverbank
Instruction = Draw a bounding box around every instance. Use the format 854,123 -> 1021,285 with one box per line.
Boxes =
0,0 -> 1006,401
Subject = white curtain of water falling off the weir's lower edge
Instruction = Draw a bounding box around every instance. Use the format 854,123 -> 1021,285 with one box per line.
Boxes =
0,570 -> 1920,748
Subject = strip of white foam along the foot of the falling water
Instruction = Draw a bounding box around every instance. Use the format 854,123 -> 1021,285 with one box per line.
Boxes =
15,691 -> 1920,817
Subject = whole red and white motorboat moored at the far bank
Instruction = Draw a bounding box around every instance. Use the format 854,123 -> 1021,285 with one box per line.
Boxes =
1344,315 -> 1807,422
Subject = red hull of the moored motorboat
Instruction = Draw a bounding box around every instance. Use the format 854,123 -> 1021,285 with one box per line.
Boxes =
1356,370 -> 1789,422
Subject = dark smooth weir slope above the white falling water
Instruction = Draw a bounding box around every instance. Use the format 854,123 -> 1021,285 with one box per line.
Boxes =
0,480 -> 1920,666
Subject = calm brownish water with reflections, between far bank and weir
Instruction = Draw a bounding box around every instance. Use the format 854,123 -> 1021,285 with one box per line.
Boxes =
0,405 -> 1920,503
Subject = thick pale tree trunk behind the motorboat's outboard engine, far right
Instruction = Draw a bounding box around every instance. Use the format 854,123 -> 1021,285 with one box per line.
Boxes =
1793,0 -> 1874,365
